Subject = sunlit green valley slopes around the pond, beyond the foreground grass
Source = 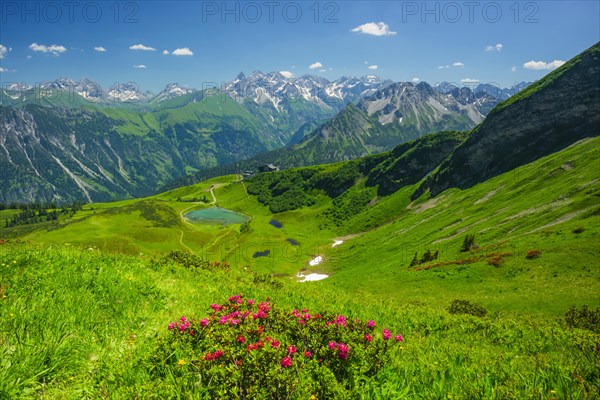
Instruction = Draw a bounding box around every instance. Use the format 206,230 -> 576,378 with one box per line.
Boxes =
0,135 -> 600,310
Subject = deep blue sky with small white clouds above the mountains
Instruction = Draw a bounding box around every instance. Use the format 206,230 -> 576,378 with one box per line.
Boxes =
0,0 -> 600,92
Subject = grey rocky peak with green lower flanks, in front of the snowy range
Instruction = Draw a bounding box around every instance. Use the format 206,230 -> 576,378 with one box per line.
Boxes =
166,78 -> 520,188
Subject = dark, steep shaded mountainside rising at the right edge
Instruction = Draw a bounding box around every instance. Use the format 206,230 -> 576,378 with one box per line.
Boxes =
418,44 -> 600,195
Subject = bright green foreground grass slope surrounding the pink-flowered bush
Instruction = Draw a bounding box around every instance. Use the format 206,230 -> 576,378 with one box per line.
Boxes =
0,239 -> 600,399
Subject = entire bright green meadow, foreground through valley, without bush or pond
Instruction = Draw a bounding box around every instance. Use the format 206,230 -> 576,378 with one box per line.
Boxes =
0,138 -> 600,399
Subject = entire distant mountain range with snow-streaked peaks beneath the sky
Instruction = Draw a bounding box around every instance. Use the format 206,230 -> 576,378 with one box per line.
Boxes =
0,71 -> 536,202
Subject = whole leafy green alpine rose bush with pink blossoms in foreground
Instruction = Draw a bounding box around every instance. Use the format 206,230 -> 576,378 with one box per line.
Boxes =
153,294 -> 403,399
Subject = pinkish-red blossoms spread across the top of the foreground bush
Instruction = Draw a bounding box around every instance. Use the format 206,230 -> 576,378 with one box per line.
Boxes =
168,294 -> 403,368
